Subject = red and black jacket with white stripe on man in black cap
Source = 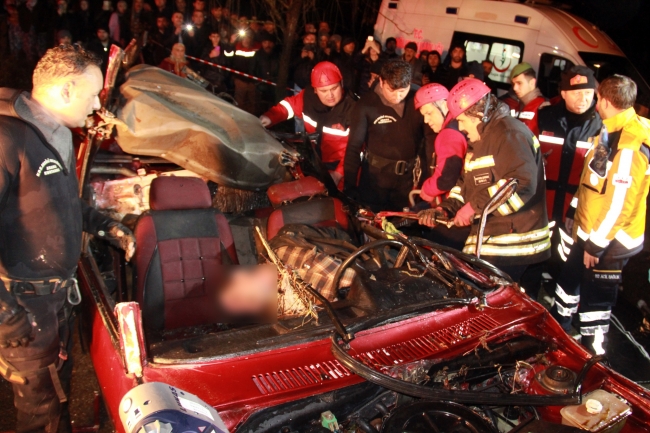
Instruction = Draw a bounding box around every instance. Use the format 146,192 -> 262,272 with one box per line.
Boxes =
537,100 -> 602,224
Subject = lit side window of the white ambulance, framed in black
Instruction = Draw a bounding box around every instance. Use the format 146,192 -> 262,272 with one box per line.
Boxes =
452,32 -> 524,89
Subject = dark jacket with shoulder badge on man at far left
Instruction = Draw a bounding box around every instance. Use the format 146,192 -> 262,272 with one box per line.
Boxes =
0,89 -> 112,282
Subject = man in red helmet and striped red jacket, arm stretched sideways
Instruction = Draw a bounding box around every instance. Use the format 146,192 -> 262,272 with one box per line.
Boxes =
260,62 -> 355,185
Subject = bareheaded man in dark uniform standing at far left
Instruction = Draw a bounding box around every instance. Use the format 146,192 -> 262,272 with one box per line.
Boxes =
0,45 -> 135,432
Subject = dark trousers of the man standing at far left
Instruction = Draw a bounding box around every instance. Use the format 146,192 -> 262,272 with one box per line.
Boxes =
0,290 -> 72,433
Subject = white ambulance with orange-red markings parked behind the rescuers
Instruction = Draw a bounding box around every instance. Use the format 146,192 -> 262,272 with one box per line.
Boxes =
374,0 -> 650,117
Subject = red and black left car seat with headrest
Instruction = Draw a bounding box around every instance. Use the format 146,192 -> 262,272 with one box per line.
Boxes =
134,177 -> 237,331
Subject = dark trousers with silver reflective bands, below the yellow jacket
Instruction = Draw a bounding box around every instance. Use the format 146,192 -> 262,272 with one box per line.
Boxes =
551,243 -> 628,336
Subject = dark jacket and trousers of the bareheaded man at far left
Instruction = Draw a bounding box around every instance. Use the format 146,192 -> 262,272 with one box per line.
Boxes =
0,89 -> 117,432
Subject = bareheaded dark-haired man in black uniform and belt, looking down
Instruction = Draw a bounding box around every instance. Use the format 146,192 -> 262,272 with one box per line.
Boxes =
344,59 -> 433,211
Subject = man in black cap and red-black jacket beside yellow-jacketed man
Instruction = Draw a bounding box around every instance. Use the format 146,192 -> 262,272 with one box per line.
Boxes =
538,66 -> 602,278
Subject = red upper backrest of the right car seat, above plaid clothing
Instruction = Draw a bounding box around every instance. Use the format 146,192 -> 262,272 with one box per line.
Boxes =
266,197 -> 348,239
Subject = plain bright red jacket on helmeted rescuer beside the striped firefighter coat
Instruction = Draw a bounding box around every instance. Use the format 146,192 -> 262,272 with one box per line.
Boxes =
420,120 -> 467,201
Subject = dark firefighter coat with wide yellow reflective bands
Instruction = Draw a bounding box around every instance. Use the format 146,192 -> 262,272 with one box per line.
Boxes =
441,103 -> 551,266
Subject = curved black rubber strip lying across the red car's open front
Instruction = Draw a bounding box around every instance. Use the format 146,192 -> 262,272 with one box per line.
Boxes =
331,336 -> 581,406
